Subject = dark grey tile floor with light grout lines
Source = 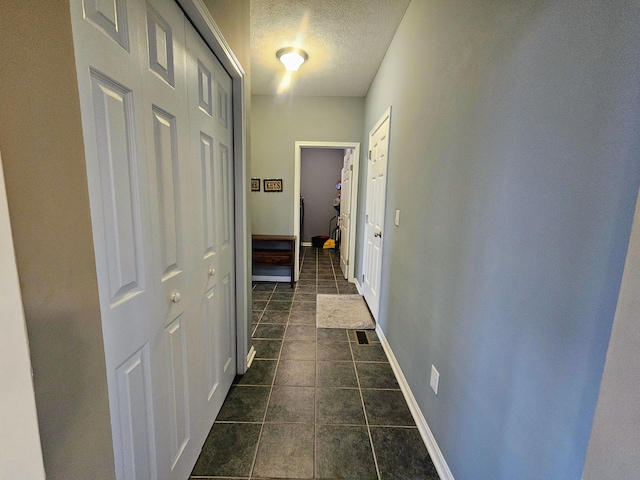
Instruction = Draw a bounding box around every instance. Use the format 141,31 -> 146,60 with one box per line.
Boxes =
190,248 -> 439,480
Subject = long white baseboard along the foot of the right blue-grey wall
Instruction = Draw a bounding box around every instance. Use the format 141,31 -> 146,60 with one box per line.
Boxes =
376,324 -> 454,480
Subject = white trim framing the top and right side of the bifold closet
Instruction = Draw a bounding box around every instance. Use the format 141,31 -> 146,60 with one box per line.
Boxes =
176,0 -> 255,374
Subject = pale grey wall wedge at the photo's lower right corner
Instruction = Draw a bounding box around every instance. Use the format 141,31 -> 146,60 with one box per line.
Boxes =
582,187 -> 640,480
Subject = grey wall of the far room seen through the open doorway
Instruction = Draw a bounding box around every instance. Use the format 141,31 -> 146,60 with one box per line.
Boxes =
300,148 -> 344,242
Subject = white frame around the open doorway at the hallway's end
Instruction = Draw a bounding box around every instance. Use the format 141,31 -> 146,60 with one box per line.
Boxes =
293,141 -> 360,283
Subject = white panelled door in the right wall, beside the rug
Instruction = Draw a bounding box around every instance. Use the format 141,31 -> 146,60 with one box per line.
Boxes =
362,108 -> 391,320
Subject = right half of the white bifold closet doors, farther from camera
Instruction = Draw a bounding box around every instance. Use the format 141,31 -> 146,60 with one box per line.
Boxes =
187,20 -> 236,435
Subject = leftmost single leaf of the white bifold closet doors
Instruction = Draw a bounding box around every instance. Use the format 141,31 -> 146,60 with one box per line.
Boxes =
71,0 -> 159,479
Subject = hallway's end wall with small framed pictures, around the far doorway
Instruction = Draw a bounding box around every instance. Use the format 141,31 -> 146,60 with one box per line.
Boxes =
251,95 -> 364,235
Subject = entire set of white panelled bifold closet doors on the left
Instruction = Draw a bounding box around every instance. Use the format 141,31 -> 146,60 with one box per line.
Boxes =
71,0 -> 236,480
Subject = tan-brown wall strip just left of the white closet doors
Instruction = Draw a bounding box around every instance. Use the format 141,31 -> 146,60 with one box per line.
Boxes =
0,1 -> 115,480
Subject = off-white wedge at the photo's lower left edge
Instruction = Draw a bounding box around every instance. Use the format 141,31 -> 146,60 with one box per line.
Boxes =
0,154 -> 45,480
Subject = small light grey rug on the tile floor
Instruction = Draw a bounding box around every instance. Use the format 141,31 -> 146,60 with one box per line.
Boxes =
316,294 -> 376,329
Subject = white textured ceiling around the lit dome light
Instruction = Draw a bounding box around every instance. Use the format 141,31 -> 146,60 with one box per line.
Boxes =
251,0 -> 410,97
